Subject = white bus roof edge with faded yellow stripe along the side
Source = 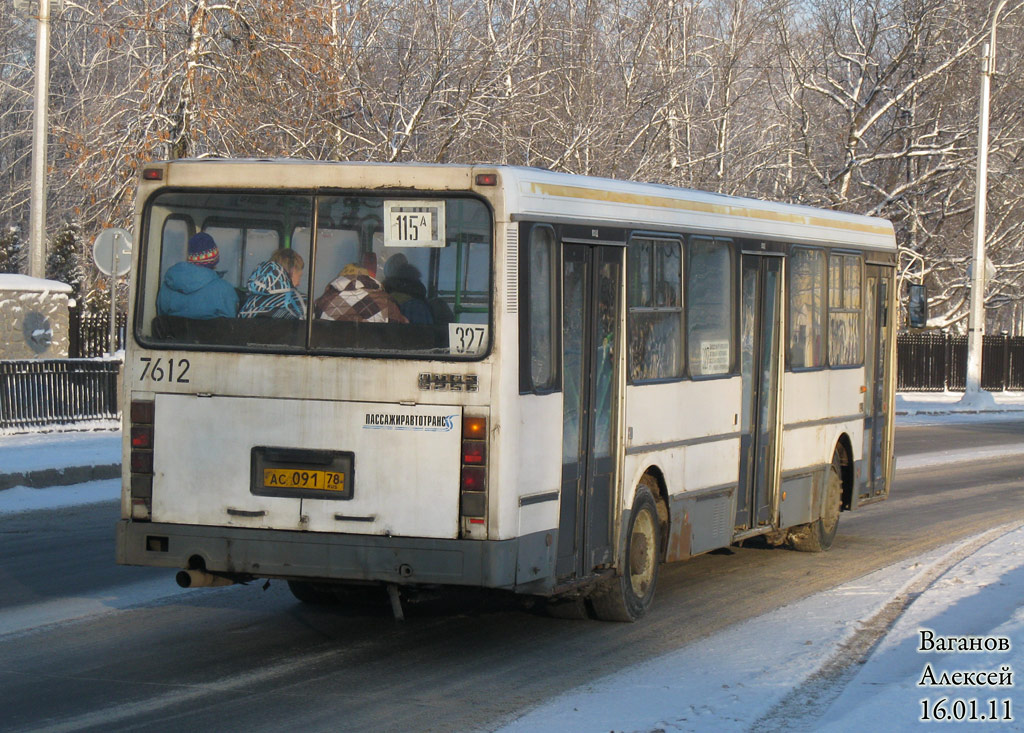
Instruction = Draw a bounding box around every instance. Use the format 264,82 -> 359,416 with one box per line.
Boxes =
151,159 -> 896,251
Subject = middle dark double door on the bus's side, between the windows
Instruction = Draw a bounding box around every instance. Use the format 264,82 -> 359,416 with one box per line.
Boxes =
735,254 -> 782,531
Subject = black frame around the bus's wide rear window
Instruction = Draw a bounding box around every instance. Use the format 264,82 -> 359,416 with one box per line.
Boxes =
130,186 -> 495,362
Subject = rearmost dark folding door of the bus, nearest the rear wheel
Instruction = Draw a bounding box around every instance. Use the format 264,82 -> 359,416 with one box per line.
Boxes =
555,244 -> 624,578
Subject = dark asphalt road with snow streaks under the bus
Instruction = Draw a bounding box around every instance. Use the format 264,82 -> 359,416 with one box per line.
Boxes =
0,420 -> 1024,731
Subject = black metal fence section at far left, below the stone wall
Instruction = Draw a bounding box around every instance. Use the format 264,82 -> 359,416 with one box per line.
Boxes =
0,359 -> 121,428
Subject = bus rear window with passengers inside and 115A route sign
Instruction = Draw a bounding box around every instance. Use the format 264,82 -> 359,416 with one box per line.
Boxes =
135,191 -> 493,358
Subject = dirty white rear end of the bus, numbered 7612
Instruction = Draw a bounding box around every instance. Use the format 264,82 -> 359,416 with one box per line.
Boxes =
118,161 -> 516,588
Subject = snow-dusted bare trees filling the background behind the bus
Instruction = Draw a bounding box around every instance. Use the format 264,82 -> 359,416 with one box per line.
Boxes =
0,0 -> 1024,329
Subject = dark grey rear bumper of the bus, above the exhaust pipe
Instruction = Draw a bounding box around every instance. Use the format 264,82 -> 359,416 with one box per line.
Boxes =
117,519 -> 557,594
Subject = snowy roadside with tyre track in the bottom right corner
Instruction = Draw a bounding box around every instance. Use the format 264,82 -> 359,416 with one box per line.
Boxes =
498,524 -> 1024,733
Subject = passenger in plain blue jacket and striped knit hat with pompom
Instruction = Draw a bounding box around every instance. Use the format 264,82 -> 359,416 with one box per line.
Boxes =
157,231 -> 239,319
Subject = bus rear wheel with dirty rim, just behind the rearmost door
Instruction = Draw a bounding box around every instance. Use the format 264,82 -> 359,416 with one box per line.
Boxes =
590,477 -> 662,622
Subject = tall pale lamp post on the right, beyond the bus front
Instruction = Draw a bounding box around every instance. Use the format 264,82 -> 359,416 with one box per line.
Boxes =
964,0 -> 1008,401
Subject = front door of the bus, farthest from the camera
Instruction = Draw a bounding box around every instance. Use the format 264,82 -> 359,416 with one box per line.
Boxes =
859,265 -> 893,499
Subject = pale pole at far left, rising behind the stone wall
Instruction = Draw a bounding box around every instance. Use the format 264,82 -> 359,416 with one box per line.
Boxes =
25,0 -> 50,277
